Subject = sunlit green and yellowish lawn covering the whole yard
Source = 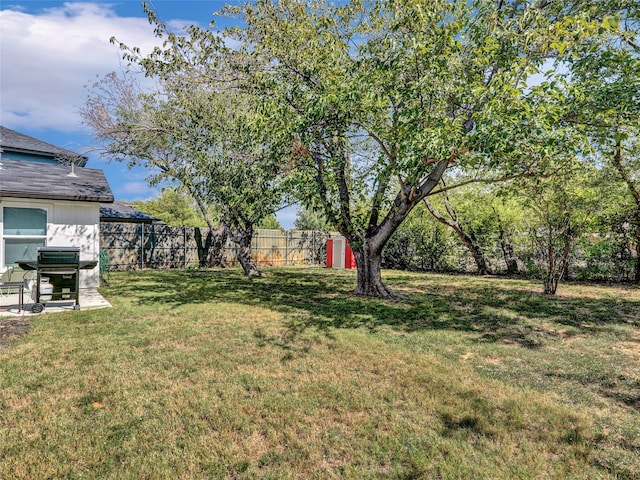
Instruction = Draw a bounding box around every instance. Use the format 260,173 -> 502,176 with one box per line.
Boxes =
0,269 -> 640,479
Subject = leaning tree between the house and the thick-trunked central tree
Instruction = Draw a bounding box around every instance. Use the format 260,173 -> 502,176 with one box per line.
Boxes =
83,11 -> 285,275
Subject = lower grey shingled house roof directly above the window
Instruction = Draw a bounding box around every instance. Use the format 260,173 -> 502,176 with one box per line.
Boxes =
0,158 -> 113,203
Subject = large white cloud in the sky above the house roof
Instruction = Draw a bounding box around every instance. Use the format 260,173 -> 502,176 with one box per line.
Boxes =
0,3 -> 162,132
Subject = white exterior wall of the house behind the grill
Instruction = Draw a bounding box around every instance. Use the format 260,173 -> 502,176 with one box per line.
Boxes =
0,198 -> 100,288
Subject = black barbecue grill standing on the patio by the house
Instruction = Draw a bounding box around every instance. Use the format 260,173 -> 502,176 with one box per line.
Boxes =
18,247 -> 98,313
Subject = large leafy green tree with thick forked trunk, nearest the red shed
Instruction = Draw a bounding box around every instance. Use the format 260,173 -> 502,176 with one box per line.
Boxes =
225,0 -> 608,296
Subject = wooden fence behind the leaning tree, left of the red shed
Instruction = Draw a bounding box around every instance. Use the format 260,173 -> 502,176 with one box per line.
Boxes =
100,222 -> 328,270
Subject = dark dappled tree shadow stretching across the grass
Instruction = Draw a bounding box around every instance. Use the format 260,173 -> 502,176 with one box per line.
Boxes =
109,269 -> 640,348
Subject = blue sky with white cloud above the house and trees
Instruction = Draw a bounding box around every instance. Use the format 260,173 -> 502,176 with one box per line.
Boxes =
0,0 -> 295,228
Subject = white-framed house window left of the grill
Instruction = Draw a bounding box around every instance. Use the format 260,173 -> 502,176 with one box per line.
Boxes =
2,207 -> 47,265
